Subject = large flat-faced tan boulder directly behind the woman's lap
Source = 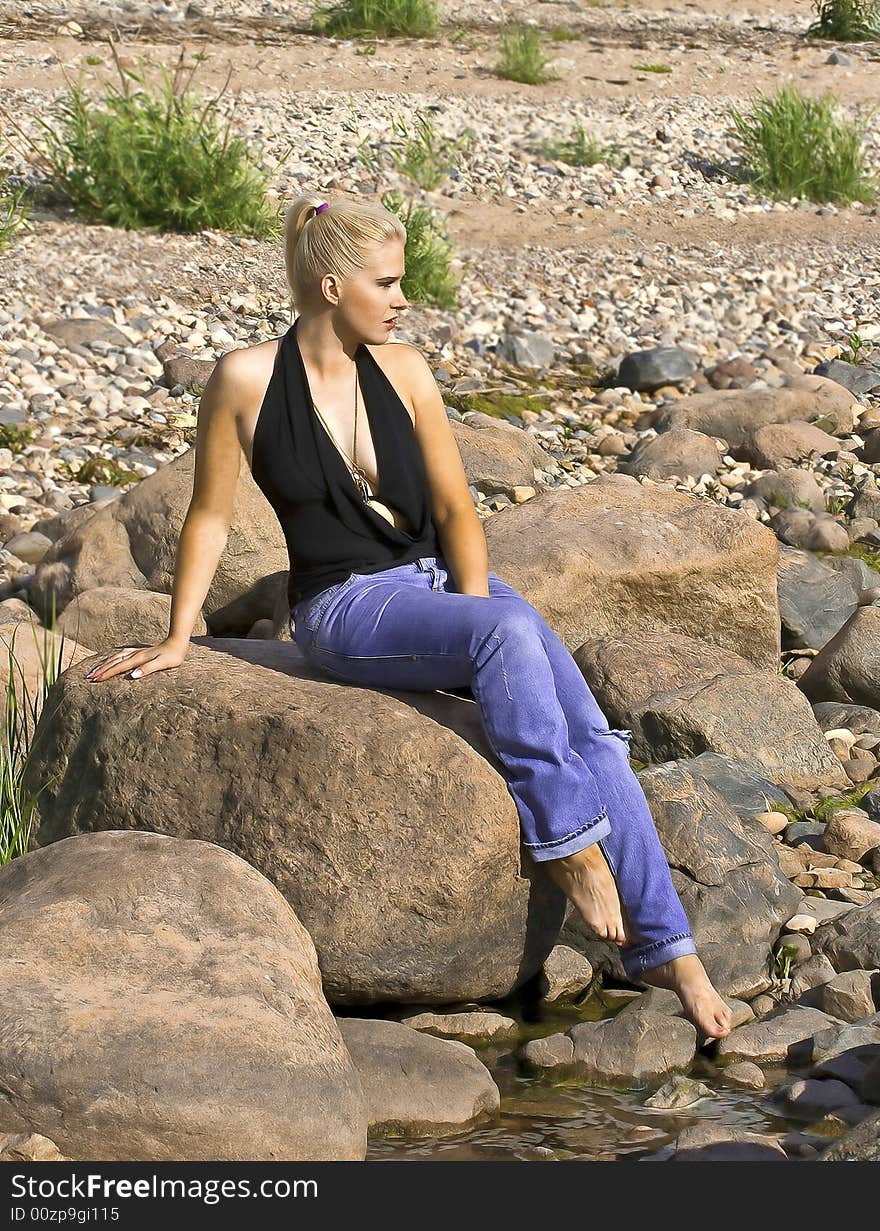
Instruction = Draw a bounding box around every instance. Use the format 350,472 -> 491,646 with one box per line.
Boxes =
485,474 -> 779,670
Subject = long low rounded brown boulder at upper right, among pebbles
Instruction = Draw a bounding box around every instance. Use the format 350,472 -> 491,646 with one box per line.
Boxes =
655,375 -> 860,460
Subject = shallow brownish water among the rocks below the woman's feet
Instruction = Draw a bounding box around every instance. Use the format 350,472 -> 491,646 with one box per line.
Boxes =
367,998 -> 832,1162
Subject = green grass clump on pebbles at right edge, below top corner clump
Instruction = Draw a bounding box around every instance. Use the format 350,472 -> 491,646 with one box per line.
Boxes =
731,85 -> 876,204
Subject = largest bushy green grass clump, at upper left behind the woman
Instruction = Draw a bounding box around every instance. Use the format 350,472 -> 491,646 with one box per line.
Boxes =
0,43 -> 282,239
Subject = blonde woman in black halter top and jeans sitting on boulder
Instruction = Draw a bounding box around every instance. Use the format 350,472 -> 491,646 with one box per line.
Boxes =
89,196 -> 731,1038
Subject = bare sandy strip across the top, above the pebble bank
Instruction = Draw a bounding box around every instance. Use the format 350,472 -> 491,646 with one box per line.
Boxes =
0,25 -> 880,106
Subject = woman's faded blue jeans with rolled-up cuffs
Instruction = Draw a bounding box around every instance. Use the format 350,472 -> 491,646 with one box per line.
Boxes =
289,555 -> 697,980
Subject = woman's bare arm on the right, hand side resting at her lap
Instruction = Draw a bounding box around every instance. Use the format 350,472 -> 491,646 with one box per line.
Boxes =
395,343 -> 489,598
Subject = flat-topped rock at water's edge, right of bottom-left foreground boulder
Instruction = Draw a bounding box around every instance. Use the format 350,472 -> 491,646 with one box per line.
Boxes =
336,1017 -> 501,1136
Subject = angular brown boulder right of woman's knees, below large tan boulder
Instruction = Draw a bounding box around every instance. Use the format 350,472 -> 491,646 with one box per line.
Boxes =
575,632 -> 848,788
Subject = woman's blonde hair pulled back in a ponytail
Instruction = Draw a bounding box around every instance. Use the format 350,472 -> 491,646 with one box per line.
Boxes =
284,193 -> 406,309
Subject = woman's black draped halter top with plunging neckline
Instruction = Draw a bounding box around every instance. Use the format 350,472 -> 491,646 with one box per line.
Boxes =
251,321 -> 438,611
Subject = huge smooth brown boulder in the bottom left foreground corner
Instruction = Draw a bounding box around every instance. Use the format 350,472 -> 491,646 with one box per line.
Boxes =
0,832 -> 367,1161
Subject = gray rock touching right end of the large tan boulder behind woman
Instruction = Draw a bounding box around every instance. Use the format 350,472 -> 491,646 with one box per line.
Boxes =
778,544 -> 858,650
